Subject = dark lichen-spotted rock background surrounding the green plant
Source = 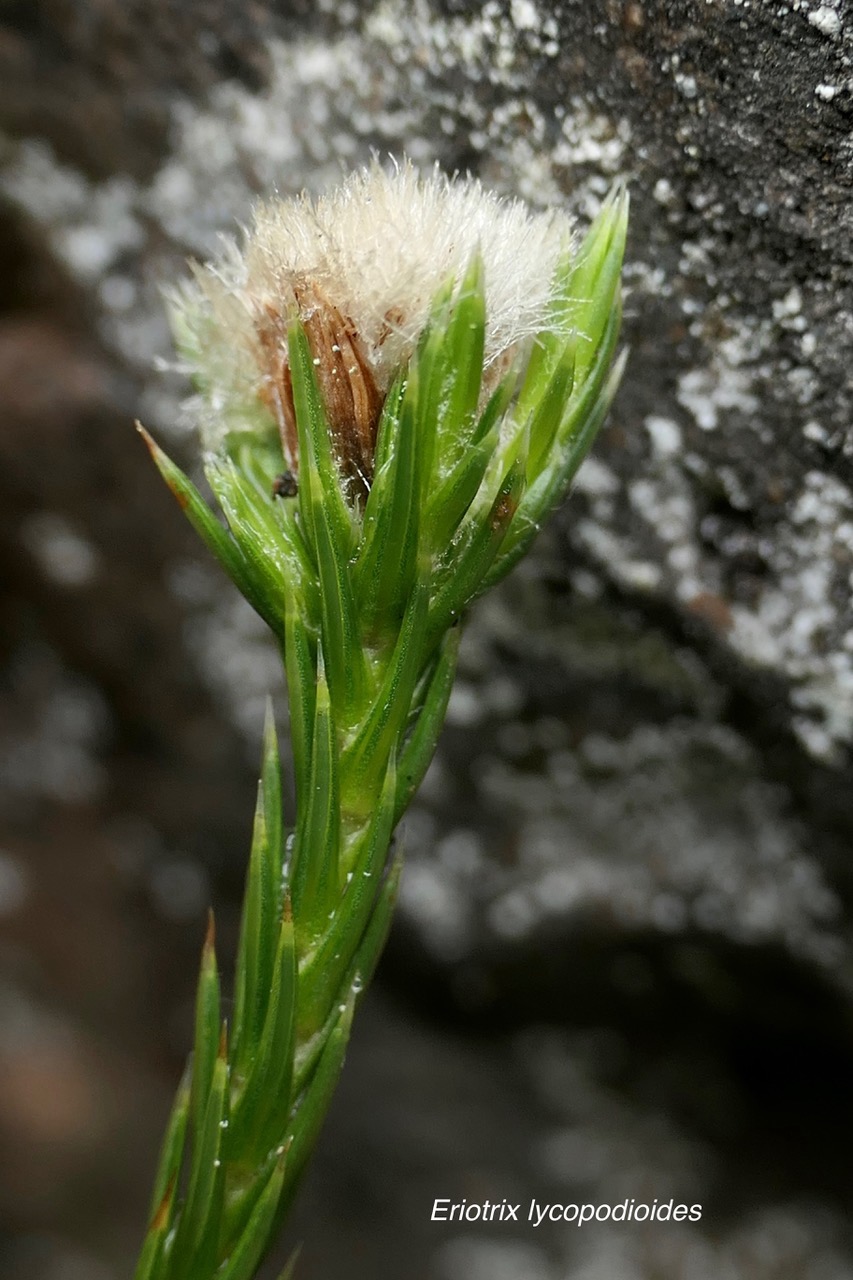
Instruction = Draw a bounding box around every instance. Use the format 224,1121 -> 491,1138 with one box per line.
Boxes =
0,0 -> 853,1280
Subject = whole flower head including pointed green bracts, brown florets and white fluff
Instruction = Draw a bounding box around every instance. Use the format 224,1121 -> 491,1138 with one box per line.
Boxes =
149,165 -> 628,675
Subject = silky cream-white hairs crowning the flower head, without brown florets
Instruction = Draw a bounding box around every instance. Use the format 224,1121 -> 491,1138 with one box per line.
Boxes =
172,161 -> 574,447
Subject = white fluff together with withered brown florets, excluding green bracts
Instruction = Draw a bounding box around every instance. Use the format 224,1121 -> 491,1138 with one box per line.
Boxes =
175,163 -> 573,490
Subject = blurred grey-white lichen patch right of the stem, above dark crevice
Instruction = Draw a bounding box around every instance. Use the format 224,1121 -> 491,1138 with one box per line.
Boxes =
401,724 -> 845,965
